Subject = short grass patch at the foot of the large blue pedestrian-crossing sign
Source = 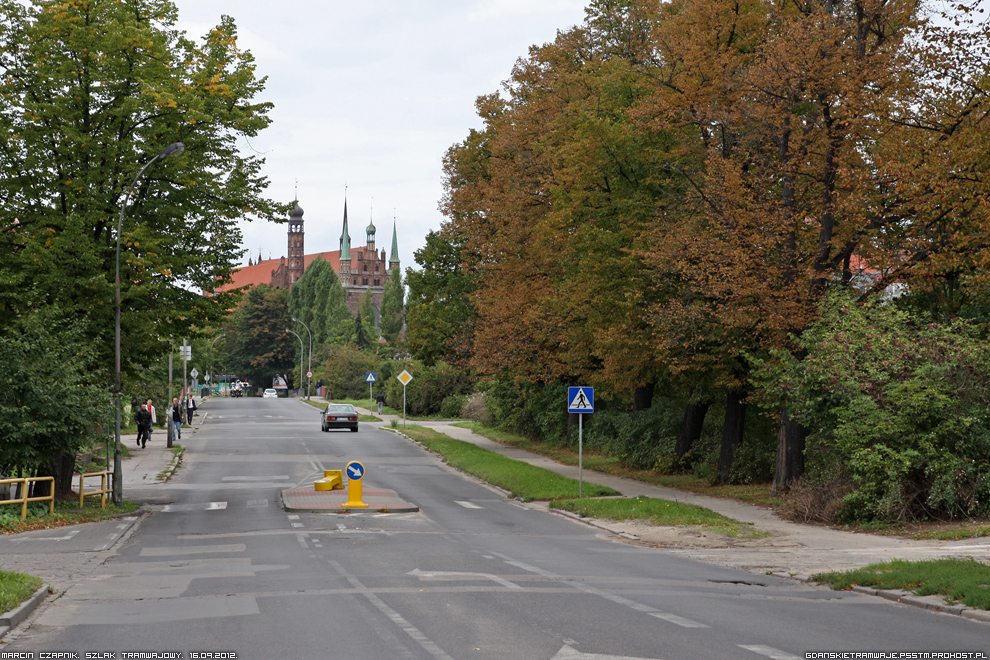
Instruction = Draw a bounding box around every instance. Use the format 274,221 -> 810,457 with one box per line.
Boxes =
550,497 -> 770,539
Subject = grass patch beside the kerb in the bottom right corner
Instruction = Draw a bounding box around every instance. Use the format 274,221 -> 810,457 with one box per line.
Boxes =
811,559 -> 990,610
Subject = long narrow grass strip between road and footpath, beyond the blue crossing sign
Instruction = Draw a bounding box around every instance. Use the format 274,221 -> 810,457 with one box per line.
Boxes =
398,425 -> 618,501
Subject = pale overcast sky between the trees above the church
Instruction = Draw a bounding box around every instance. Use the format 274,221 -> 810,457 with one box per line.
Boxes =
175,0 -> 587,270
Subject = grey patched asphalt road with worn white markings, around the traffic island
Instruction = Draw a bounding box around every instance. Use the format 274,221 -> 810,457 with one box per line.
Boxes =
3,398 -> 990,660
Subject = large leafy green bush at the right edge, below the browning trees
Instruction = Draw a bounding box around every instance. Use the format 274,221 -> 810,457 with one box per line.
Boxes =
760,295 -> 990,520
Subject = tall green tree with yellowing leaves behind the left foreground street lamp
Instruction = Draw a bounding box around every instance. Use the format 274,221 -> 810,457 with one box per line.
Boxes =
0,0 -> 286,372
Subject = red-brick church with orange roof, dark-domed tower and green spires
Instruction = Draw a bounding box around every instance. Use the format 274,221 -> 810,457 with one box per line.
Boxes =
223,200 -> 399,316
